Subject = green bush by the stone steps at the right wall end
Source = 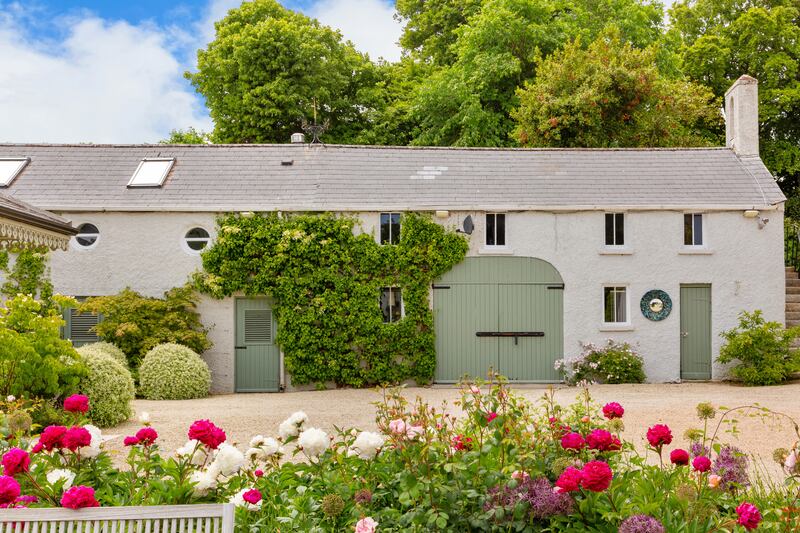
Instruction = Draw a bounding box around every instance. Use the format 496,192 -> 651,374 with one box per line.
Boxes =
717,310 -> 800,385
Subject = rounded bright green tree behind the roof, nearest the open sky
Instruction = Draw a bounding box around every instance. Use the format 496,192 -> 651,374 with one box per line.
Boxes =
191,0 -> 378,143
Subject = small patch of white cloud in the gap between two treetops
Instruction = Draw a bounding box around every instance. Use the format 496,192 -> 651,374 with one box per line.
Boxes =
308,0 -> 403,61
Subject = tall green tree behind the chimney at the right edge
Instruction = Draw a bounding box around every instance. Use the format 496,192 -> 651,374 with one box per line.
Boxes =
670,0 -> 800,193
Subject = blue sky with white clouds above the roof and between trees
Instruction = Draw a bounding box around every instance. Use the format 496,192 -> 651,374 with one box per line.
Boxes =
0,0 -> 400,143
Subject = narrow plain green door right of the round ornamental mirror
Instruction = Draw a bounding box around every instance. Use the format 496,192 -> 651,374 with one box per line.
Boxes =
680,285 -> 711,380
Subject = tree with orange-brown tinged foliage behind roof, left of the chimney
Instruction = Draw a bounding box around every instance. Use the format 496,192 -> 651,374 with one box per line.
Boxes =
513,32 -> 721,147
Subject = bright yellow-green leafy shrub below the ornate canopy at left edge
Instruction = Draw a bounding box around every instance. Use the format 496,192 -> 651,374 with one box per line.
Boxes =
0,294 -> 86,398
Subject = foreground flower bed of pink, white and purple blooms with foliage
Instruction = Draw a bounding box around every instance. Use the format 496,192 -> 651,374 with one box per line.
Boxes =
0,383 -> 800,533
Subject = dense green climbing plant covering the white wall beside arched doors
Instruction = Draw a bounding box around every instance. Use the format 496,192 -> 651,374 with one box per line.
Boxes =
195,214 -> 468,387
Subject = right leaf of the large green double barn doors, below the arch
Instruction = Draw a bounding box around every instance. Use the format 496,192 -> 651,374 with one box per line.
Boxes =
498,284 -> 564,382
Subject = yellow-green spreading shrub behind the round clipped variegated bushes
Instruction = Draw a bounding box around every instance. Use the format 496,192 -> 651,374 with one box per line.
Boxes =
80,286 -> 211,368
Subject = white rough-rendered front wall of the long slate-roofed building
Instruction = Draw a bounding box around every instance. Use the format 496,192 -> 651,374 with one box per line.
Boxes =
45,211 -> 785,392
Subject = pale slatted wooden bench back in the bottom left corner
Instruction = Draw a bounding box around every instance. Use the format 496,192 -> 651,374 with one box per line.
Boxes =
0,503 -> 234,533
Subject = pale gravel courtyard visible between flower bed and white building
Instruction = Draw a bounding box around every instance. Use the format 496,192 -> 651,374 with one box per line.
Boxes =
105,382 -> 800,478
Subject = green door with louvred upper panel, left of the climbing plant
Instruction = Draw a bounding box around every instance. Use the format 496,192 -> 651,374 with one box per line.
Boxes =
236,298 -> 280,392
